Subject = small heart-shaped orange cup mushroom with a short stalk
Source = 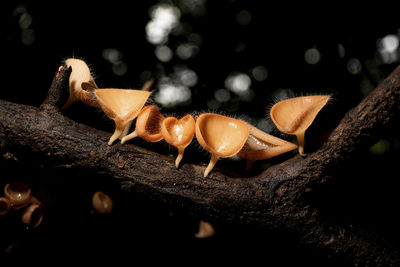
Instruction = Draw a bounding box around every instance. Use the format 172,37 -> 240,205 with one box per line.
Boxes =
161,114 -> 196,168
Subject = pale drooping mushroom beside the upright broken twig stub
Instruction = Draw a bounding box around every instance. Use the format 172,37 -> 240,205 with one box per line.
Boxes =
61,58 -> 98,110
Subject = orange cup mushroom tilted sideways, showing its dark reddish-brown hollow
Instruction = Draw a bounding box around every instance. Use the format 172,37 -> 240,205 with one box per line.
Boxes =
121,105 -> 164,144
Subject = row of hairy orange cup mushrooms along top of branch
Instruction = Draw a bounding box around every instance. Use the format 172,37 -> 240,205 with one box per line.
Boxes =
63,59 -> 329,177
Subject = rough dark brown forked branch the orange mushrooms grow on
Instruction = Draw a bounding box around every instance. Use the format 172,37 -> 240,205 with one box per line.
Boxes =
0,67 -> 400,266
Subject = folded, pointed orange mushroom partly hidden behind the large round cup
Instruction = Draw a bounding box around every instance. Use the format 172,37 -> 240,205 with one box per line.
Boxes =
238,123 -> 297,161
